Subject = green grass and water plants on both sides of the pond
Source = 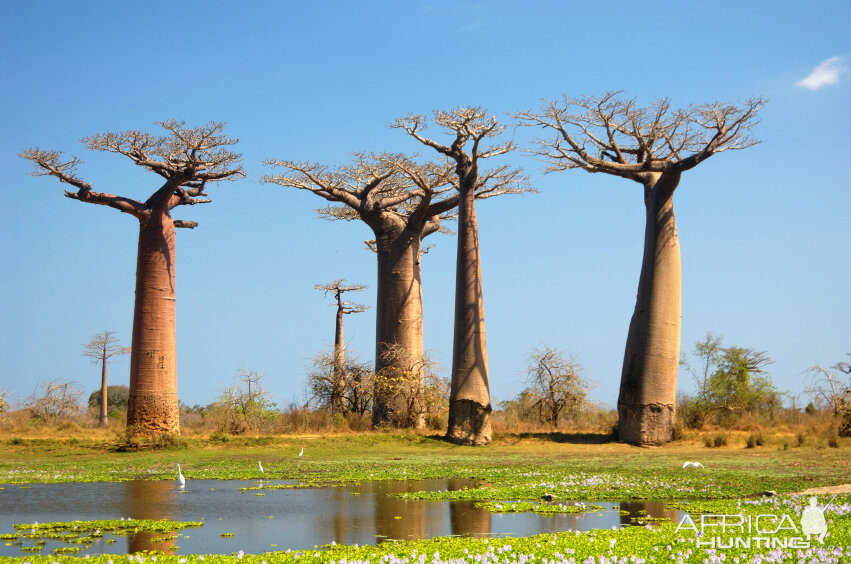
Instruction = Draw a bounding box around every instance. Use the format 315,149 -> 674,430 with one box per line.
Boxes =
0,433 -> 851,564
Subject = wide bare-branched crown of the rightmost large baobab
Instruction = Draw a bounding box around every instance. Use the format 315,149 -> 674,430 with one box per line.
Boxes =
514,92 -> 765,182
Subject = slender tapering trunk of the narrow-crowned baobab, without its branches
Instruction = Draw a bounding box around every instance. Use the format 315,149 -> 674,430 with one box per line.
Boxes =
446,187 -> 491,445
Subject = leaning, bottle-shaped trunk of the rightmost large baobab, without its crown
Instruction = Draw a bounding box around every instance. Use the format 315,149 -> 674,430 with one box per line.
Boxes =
618,175 -> 681,445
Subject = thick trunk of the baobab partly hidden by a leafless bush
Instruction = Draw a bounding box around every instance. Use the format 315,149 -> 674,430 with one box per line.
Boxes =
372,228 -> 423,427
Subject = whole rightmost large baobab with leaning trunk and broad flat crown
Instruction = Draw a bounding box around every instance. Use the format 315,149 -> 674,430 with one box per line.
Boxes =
516,92 -> 765,445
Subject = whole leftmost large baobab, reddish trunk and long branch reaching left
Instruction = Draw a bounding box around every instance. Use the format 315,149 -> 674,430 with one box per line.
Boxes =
20,120 -> 243,434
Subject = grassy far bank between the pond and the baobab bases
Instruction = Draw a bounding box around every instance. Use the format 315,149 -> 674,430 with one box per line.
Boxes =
0,433 -> 851,497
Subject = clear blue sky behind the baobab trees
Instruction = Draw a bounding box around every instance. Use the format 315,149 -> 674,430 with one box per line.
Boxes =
0,1 -> 851,412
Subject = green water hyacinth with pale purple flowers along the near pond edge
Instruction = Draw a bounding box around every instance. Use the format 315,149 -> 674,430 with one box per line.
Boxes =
1,495 -> 851,564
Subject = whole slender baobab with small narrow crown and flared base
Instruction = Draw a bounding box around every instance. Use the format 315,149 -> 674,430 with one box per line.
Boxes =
392,107 -> 530,445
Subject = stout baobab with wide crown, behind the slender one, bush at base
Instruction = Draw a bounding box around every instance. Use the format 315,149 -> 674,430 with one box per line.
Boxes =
261,153 -> 457,426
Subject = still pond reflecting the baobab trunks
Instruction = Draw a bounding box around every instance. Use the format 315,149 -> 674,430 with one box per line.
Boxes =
0,479 -> 682,556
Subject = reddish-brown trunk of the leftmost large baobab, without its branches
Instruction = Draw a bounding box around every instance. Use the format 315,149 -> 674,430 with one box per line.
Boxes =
127,209 -> 180,434
